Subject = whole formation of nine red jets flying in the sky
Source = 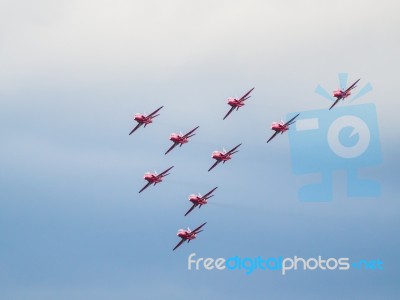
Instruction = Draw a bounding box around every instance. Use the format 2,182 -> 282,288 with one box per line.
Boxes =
129,79 -> 360,250
